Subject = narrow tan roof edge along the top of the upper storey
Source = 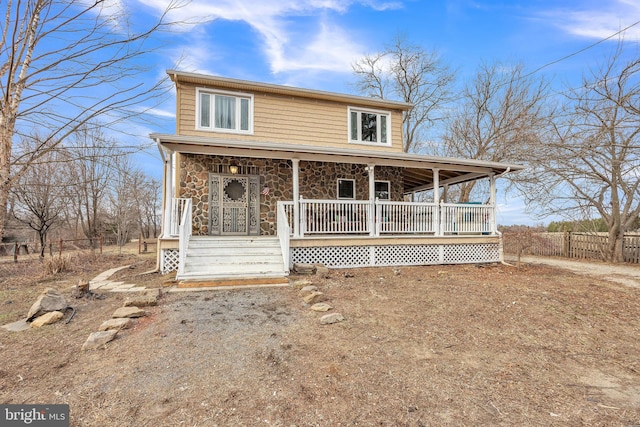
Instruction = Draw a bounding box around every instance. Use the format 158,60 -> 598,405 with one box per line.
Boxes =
167,70 -> 413,111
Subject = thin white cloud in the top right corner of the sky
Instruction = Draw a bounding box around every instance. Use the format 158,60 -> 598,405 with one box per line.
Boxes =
545,0 -> 640,40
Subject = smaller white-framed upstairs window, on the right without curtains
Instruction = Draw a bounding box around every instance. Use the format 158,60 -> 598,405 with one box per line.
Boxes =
349,108 -> 391,145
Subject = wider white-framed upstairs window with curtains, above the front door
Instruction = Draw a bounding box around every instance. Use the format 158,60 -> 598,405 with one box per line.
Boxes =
196,89 -> 253,133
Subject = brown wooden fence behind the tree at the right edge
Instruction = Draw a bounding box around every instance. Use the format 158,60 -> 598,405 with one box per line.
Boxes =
503,232 -> 640,264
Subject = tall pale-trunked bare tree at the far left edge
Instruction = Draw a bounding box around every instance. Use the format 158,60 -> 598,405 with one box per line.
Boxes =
0,0 -> 176,240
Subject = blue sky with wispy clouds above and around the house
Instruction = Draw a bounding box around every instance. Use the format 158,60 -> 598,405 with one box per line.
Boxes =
125,0 -> 640,224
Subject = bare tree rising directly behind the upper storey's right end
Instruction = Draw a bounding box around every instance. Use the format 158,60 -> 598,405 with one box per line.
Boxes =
352,36 -> 455,152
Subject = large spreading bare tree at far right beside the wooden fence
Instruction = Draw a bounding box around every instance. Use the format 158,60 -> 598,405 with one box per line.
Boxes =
519,43 -> 640,262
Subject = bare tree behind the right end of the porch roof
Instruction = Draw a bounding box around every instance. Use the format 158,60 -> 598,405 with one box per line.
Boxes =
442,62 -> 551,202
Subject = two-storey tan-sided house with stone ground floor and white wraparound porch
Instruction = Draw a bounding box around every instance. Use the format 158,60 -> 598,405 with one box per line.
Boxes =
150,70 -> 522,280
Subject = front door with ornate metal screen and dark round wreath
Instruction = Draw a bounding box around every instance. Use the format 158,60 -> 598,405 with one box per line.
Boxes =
209,174 -> 260,236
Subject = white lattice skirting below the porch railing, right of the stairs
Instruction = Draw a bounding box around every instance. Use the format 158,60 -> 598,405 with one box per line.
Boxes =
291,243 -> 500,268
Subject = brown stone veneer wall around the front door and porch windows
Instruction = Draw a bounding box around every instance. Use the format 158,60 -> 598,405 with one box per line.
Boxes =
179,154 -> 403,235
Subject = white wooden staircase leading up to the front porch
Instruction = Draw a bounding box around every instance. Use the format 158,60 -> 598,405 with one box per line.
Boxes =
176,236 -> 287,287
